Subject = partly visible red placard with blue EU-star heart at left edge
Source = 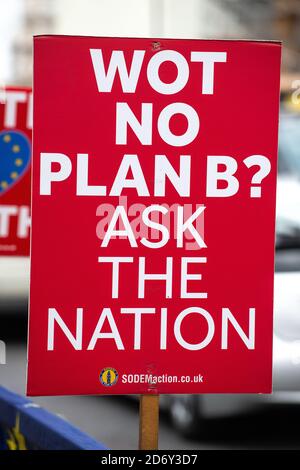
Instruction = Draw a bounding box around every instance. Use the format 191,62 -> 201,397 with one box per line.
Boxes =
0,87 -> 32,256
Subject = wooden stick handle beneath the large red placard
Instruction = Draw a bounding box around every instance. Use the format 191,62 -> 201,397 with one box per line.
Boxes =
139,395 -> 159,450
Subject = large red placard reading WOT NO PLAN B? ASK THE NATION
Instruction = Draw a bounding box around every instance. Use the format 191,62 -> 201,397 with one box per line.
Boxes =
28,36 -> 281,395
